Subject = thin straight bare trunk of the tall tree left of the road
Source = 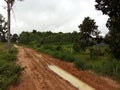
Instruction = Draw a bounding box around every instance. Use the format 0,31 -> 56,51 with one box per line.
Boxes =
7,2 -> 11,52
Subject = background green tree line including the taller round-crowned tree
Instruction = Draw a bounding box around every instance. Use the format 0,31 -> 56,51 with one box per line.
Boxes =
19,17 -> 104,51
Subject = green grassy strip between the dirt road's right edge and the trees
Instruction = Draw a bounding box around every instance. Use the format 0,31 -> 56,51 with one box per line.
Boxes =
35,44 -> 120,82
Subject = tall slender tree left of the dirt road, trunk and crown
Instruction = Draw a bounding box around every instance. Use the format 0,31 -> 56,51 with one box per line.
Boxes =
4,0 -> 22,52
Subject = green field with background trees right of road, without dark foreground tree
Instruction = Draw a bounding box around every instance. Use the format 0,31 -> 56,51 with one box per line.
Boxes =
19,27 -> 120,81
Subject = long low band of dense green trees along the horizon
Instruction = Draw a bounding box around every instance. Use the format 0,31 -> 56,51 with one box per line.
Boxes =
19,30 -> 80,46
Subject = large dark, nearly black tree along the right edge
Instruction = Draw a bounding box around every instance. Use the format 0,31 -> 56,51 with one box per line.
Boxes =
95,0 -> 120,59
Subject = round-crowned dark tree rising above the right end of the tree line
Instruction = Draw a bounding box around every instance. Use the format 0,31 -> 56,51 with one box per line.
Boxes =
78,17 -> 98,48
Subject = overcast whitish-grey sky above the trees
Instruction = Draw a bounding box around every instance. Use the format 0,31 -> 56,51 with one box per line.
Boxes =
0,0 -> 108,36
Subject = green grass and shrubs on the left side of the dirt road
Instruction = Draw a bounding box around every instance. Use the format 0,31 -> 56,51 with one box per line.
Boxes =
0,43 -> 23,90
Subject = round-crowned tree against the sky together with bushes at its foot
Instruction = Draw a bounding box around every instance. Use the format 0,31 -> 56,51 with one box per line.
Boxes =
73,17 -> 100,52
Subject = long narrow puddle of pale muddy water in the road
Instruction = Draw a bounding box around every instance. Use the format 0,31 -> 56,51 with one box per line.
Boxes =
48,65 -> 95,90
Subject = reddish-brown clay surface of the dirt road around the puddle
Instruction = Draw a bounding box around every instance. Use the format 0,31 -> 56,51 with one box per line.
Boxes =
9,47 -> 119,90
